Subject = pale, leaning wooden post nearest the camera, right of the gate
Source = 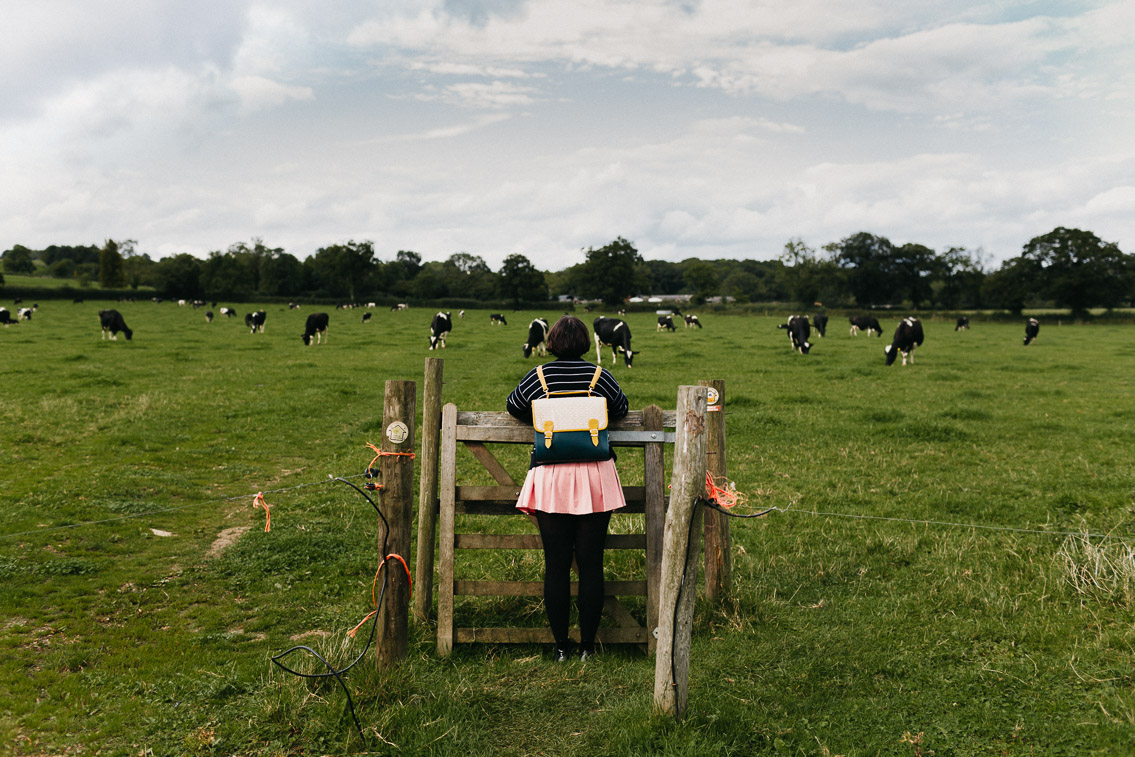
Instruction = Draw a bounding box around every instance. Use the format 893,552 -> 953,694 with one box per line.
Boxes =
654,386 -> 707,717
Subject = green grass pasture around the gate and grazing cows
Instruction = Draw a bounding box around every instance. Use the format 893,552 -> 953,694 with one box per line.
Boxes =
0,302 -> 1135,756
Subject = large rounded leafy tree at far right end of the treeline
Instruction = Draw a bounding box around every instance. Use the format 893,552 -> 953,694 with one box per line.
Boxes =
1020,226 -> 1135,314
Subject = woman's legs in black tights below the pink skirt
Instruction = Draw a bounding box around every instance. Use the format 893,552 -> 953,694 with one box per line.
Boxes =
536,511 -> 611,649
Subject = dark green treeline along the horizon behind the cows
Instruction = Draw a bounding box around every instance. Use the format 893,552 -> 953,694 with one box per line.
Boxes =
0,227 -> 1135,313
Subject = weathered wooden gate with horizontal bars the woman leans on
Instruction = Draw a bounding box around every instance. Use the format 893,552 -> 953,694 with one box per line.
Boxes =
418,398 -> 675,655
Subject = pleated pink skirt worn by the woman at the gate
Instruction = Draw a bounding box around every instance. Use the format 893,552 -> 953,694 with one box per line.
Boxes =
516,460 -> 627,515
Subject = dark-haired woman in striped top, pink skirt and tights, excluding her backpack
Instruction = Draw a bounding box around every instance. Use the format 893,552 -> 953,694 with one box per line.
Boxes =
506,316 -> 630,662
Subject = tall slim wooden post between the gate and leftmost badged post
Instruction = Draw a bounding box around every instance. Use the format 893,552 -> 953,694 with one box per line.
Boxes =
414,358 -> 445,622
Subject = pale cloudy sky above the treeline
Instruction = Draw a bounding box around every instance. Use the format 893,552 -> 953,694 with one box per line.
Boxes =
0,0 -> 1135,270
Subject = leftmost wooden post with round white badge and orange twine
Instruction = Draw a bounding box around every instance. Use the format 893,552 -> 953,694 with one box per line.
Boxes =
376,381 -> 418,670
